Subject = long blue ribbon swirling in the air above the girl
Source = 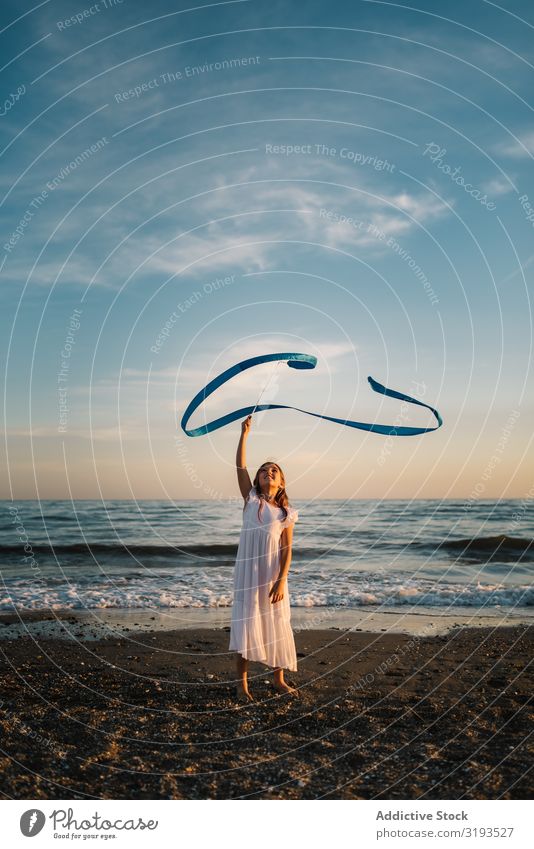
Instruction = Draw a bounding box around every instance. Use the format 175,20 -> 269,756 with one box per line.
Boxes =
181,354 -> 443,436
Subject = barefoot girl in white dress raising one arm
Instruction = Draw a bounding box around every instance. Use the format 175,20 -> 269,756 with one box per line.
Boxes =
230,416 -> 299,701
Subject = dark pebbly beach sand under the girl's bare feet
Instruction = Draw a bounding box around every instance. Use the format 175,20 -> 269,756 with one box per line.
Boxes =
0,626 -> 534,799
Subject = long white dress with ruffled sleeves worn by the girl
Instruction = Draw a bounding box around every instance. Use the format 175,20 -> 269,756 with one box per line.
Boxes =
230,487 -> 298,672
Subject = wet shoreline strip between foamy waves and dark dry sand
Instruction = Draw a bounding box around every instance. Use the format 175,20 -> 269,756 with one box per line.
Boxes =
0,607 -> 534,642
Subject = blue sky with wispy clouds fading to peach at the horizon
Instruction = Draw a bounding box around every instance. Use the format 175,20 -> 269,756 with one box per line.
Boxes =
0,0 -> 534,500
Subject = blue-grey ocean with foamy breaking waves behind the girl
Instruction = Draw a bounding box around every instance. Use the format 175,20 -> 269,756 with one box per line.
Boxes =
0,499 -> 534,614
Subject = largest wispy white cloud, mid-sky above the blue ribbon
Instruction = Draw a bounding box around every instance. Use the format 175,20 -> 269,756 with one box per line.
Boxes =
129,169 -> 448,276
